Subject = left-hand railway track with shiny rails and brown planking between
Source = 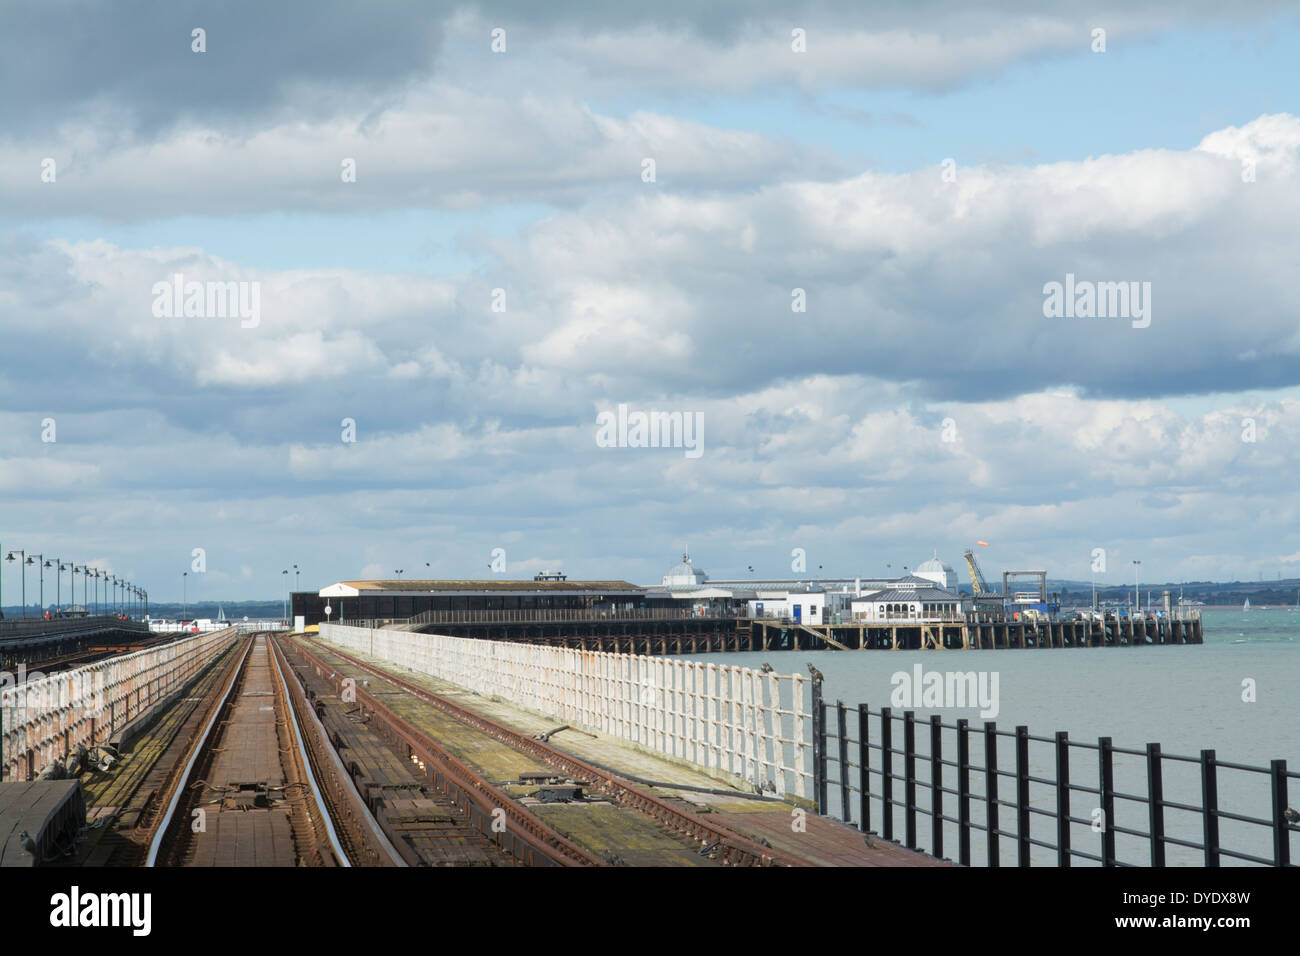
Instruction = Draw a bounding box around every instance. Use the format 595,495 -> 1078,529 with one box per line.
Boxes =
147,635 -> 361,866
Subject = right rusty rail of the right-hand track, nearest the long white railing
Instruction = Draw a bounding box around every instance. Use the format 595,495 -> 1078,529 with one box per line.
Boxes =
298,634 -> 803,866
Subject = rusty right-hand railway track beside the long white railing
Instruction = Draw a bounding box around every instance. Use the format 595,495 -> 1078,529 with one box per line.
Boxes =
293,640 -> 806,866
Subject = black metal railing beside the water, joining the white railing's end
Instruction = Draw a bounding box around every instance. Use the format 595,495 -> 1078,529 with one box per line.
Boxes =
813,691 -> 1300,866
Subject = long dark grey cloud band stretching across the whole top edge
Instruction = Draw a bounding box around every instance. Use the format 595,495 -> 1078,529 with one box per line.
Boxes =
0,0 -> 1294,138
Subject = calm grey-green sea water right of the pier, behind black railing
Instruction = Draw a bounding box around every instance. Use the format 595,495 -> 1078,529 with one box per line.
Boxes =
689,609 -> 1300,866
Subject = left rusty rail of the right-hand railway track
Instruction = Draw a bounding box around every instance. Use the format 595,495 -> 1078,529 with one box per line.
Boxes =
284,641 -> 608,866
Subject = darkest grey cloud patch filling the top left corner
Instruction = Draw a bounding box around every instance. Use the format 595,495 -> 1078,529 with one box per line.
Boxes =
0,0 -> 442,137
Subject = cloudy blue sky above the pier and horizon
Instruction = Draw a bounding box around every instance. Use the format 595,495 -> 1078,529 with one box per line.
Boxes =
0,0 -> 1300,604
